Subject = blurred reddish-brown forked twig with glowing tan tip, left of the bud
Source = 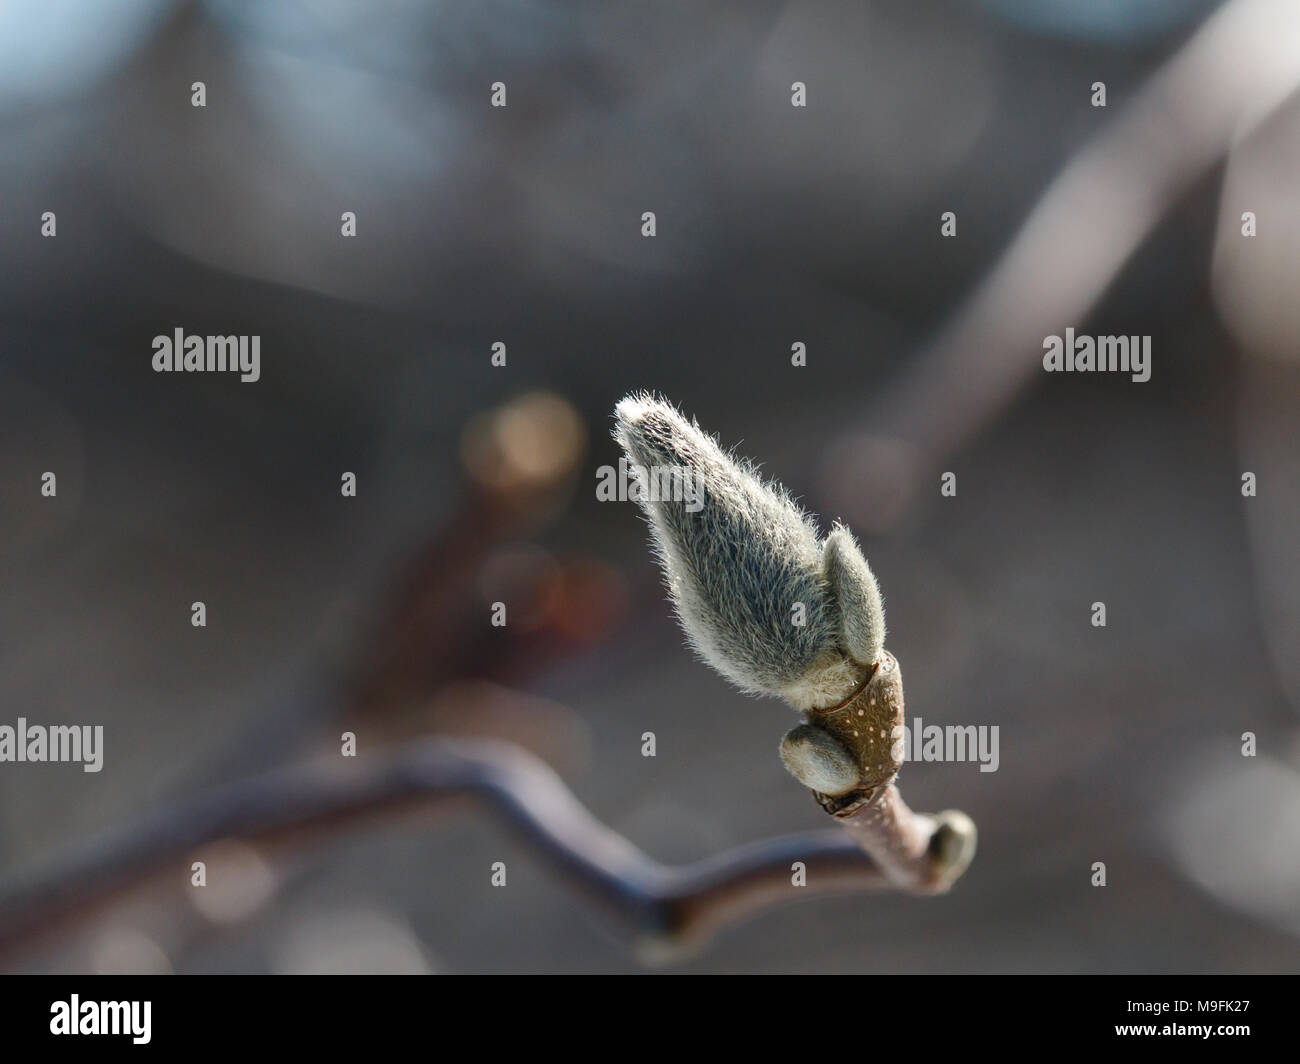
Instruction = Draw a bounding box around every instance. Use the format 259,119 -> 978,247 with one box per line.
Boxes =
196,392 -> 608,786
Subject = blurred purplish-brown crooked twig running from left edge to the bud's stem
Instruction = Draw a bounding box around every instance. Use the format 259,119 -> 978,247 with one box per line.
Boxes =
0,740 -> 891,970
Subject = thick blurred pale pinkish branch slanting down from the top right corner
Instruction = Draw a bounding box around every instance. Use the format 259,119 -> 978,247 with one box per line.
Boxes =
826,0 -> 1300,532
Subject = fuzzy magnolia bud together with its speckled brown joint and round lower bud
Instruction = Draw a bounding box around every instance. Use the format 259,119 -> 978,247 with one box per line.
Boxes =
614,394 -> 902,796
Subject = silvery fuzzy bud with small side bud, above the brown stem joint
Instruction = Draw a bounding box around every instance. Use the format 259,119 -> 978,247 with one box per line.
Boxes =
614,393 -> 885,710
